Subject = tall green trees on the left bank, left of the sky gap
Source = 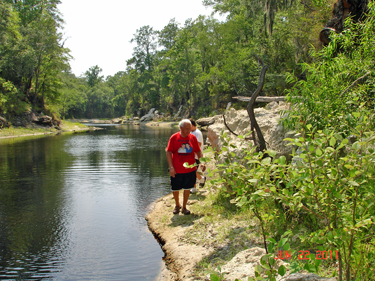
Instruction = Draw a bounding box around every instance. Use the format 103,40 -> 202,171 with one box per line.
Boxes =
0,0 -> 68,117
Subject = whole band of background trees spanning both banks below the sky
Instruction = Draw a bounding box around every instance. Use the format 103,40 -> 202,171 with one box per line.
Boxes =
0,0 -> 328,118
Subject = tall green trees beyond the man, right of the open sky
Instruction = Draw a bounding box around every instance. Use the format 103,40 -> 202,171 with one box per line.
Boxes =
104,1 -> 320,117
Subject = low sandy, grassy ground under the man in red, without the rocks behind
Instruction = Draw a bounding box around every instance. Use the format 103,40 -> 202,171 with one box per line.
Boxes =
146,170 -> 265,281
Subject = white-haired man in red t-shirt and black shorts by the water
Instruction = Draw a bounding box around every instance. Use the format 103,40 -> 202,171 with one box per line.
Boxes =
166,119 -> 203,215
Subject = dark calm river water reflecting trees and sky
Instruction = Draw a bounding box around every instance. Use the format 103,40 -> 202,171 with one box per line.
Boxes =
0,125 -> 176,281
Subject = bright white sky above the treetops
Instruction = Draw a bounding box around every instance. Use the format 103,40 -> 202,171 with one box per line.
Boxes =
58,0 -> 220,77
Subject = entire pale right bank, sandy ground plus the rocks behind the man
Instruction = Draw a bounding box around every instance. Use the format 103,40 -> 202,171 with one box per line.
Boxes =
146,104 -> 336,281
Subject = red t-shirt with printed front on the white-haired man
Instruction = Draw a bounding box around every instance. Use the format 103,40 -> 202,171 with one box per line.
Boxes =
167,132 -> 201,174
